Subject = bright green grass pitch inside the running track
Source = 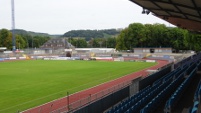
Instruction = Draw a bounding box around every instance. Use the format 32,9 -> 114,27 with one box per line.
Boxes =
0,60 -> 156,113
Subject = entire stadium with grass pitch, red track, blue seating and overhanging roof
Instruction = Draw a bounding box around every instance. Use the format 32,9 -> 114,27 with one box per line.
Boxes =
0,0 -> 201,113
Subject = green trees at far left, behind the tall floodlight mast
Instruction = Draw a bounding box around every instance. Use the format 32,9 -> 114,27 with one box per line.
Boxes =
0,29 -> 50,50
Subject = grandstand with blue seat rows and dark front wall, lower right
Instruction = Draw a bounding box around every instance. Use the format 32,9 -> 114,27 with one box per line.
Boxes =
68,53 -> 201,113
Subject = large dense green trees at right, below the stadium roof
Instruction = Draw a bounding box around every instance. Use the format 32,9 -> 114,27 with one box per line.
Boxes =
116,23 -> 201,51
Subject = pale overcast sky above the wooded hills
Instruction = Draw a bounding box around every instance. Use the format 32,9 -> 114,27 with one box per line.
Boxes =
0,0 -> 172,34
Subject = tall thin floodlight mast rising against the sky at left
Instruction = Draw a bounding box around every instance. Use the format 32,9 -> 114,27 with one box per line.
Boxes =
11,0 -> 16,51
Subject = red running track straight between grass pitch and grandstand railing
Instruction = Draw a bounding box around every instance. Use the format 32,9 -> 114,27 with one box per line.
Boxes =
23,61 -> 168,113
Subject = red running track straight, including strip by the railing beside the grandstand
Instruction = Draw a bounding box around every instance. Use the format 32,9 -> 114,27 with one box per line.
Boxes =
23,61 -> 168,113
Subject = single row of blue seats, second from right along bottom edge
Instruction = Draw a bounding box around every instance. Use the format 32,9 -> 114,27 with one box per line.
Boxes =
164,68 -> 197,113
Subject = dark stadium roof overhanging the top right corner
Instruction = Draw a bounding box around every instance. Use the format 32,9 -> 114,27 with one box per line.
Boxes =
130,0 -> 201,32
